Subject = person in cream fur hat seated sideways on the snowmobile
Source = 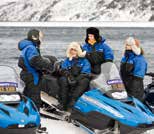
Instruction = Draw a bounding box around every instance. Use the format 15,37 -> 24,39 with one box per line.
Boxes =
59,42 -> 91,110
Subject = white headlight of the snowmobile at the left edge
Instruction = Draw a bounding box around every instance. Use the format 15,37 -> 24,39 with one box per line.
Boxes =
0,94 -> 21,103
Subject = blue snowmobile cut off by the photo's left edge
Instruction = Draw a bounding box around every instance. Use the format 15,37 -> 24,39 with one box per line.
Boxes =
0,65 -> 40,134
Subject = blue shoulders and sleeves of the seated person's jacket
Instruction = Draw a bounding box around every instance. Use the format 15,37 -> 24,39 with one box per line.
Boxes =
61,58 -> 91,74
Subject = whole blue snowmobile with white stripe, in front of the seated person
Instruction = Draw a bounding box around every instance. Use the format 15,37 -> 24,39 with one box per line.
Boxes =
41,62 -> 154,134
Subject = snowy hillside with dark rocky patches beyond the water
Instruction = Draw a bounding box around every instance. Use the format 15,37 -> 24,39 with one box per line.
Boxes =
0,0 -> 152,21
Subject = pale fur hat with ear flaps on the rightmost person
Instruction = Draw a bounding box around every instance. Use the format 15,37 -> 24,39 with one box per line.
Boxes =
125,37 -> 141,55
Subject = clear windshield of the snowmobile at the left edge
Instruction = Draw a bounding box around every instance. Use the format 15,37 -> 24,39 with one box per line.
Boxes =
0,65 -> 24,92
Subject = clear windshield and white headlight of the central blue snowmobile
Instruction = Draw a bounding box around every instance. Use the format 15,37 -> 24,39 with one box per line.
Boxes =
90,62 -> 127,99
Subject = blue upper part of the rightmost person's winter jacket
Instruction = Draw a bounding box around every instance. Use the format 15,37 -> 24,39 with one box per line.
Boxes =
121,52 -> 147,78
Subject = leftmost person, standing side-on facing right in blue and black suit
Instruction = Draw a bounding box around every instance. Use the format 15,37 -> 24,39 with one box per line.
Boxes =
18,29 -> 59,110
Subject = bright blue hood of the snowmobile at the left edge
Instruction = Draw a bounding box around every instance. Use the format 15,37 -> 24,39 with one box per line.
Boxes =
0,98 -> 40,128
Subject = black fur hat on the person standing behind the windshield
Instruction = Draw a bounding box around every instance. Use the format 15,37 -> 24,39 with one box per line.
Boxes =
86,27 -> 100,41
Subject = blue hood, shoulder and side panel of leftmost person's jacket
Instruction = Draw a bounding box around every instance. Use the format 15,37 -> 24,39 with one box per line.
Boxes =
18,39 -> 40,85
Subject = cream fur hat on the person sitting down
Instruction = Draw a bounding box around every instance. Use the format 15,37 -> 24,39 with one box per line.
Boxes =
66,42 -> 86,60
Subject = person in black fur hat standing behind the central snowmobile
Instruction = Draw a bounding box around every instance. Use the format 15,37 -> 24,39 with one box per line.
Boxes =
82,27 -> 114,74
